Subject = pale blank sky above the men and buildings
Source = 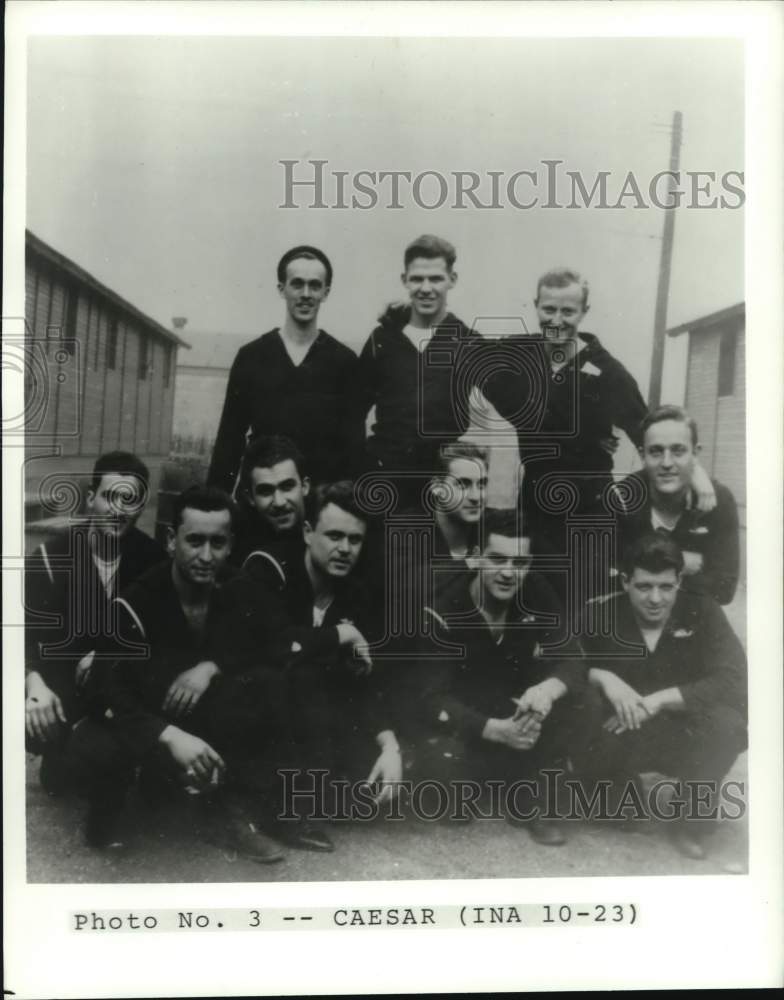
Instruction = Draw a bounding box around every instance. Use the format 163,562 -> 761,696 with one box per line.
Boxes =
27,37 -> 744,399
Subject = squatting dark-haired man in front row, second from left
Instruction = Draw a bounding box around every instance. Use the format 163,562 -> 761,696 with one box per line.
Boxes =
69,486 -> 331,862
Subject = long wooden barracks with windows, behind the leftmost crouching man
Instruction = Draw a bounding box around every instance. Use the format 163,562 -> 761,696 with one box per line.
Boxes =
24,230 -> 188,532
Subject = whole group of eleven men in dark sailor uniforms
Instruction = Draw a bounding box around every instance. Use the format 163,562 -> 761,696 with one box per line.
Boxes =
25,236 -> 746,862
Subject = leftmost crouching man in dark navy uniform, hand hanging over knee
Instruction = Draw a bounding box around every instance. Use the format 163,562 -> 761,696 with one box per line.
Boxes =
25,451 -> 166,792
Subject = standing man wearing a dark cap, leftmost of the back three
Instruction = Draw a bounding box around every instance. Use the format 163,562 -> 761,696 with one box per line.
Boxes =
208,246 -> 364,493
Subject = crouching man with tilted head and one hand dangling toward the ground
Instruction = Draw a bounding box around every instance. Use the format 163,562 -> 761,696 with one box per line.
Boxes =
244,481 -> 402,801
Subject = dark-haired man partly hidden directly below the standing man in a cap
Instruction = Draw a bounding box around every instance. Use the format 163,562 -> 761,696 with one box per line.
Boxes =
232,435 -> 310,566
